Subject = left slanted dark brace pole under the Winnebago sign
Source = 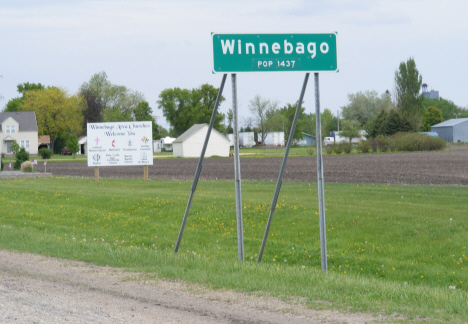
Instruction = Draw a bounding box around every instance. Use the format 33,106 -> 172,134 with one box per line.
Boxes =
174,74 -> 227,253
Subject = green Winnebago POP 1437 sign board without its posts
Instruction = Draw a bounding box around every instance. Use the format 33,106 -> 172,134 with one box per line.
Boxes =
211,33 -> 338,73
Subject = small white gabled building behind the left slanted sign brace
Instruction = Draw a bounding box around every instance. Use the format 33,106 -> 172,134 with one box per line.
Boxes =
172,124 -> 230,158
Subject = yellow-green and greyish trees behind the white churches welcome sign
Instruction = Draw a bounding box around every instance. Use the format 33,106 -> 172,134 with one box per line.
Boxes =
3,72 -> 164,153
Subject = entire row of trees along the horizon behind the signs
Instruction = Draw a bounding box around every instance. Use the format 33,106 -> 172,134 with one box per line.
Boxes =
3,58 -> 468,153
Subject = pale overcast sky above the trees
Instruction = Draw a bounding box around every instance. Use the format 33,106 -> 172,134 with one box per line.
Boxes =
0,0 -> 468,126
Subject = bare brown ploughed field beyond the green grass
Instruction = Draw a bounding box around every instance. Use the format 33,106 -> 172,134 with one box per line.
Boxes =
36,145 -> 468,185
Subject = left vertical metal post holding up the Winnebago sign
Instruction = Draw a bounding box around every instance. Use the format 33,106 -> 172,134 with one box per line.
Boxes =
231,74 -> 244,261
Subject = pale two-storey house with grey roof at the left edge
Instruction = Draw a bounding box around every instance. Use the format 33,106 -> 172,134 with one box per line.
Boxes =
0,111 -> 38,155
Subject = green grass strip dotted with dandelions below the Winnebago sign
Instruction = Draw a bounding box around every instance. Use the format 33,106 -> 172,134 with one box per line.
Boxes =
0,178 -> 468,322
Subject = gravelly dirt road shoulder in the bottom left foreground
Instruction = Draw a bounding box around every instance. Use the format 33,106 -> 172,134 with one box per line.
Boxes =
0,250 -> 388,324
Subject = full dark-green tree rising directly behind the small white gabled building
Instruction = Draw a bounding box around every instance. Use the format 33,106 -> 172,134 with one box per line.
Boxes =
157,84 -> 225,137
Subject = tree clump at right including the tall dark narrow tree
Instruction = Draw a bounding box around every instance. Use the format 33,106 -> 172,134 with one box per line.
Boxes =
342,58 -> 468,138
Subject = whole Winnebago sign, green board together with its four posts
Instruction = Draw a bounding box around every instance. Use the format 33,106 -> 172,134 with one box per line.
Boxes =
174,33 -> 338,264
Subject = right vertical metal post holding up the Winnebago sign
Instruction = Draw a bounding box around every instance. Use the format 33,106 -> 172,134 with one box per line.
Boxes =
314,73 -> 327,272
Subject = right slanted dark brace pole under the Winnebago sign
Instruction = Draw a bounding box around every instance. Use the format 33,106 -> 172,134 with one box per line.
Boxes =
257,73 -> 309,263
